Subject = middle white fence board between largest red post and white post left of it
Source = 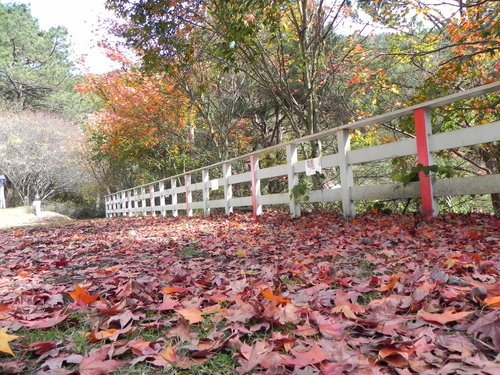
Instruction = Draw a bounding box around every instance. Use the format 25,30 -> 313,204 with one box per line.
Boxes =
347,138 -> 417,165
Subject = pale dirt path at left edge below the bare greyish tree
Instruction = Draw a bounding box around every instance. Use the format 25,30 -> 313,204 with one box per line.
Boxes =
0,207 -> 72,230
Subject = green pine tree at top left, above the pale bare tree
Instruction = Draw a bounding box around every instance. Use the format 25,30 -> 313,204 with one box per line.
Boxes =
0,4 -> 80,115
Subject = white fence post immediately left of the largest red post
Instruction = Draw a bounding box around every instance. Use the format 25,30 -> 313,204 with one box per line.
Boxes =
337,129 -> 356,218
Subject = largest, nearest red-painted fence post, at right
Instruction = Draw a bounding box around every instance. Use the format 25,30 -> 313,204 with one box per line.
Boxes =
413,108 -> 439,219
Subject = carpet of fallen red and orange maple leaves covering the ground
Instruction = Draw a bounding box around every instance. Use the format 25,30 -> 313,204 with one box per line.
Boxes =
0,212 -> 500,375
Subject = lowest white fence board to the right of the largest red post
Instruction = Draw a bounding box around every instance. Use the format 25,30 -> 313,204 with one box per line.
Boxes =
434,174 -> 500,196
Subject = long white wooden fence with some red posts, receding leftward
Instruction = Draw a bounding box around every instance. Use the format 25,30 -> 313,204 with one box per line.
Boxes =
105,81 -> 500,217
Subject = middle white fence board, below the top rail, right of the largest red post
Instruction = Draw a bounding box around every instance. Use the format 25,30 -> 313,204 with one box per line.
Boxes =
429,121 -> 500,152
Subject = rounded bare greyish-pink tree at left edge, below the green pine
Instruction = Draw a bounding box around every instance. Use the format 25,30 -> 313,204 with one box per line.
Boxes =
0,111 -> 85,205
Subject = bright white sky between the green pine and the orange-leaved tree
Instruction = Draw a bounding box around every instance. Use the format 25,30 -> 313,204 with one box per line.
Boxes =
0,0 -> 118,73
